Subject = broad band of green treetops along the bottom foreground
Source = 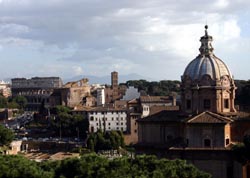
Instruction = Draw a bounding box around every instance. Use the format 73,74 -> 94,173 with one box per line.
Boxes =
0,154 -> 211,178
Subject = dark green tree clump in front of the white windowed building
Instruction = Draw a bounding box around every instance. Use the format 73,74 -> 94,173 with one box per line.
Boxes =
87,130 -> 125,152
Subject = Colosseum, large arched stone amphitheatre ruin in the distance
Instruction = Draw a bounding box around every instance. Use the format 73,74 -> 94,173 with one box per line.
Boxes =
11,77 -> 63,111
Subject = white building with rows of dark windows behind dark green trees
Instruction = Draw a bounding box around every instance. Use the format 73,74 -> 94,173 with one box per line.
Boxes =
87,107 -> 127,132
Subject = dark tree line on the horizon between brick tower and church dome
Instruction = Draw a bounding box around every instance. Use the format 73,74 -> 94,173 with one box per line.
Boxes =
125,80 -> 180,96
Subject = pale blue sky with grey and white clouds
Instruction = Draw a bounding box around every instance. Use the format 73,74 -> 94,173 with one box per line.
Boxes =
0,0 -> 250,80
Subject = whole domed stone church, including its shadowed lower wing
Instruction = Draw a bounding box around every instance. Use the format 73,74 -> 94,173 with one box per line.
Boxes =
137,26 -> 247,178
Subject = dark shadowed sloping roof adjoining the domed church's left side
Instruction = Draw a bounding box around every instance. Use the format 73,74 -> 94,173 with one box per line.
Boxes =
137,110 -> 183,122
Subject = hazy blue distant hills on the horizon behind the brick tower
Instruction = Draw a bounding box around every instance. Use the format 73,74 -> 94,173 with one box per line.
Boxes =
63,73 -> 150,84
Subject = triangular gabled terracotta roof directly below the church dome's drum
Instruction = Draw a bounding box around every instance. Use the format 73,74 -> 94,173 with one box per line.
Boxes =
185,111 -> 233,124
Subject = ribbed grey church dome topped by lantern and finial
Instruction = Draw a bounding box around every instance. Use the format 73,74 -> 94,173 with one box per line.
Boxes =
183,25 -> 232,81
